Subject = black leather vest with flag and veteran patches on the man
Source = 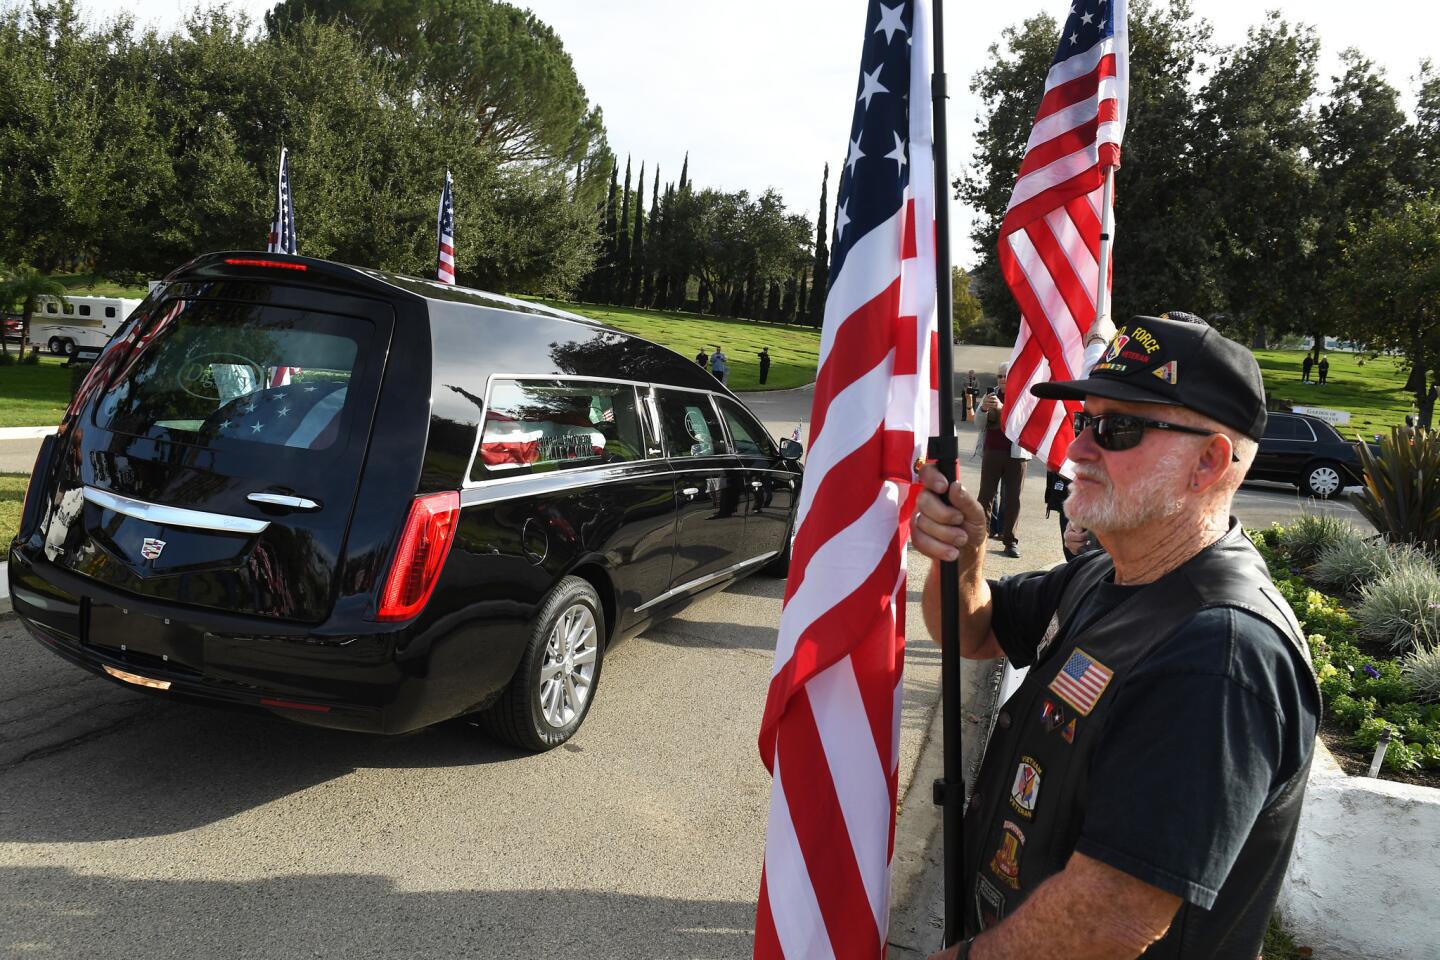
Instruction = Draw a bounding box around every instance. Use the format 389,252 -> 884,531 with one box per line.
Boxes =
963,521 -> 1319,960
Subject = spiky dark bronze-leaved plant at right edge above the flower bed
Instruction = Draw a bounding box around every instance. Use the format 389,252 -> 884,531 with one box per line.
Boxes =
1351,426 -> 1440,553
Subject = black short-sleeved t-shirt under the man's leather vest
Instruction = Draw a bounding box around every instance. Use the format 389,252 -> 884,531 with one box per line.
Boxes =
991,566 -> 1319,956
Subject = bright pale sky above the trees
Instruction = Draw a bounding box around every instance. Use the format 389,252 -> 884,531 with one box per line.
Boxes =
81,0 -> 1440,266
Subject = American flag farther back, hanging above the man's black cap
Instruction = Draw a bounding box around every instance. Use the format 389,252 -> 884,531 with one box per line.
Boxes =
999,0 -> 1129,469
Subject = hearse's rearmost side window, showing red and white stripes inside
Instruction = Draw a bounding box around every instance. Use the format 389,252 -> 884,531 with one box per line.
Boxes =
471,380 -> 645,479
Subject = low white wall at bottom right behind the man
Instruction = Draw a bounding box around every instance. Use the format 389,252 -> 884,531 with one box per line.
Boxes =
1279,743 -> 1440,960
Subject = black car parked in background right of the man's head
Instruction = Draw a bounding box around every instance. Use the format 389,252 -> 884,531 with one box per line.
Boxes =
1246,413 -> 1365,499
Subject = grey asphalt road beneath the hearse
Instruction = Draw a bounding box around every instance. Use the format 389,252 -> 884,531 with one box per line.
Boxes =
0,379 -> 1354,960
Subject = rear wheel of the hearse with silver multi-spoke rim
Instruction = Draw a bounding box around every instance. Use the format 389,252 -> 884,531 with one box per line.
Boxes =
481,577 -> 606,751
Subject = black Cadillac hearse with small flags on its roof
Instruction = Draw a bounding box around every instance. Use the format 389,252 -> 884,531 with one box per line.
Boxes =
10,253 -> 801,750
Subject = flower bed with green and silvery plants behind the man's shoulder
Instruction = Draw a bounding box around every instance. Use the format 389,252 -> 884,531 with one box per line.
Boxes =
1254,518 -> 1440,786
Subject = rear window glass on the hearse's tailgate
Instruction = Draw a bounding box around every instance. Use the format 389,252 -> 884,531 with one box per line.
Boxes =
95,301 -> 370,450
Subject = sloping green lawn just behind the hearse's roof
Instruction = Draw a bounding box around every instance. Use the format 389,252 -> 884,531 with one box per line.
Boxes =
543,301 -> 819,390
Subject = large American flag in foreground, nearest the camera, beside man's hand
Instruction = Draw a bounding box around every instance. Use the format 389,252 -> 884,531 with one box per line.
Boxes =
755,0 -> 936,960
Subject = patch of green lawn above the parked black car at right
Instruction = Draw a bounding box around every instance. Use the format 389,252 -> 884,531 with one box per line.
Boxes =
1254,350 -> 1414,440
